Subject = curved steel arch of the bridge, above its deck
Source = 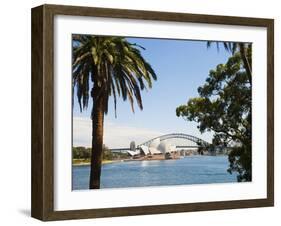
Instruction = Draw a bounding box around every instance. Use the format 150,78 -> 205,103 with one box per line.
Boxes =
138,133 -> 210,147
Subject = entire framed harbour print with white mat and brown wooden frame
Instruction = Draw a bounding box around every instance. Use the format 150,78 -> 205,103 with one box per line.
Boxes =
31,5 -> 274,221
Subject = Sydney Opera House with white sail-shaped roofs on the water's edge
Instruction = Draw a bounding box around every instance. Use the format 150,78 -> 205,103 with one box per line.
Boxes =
128,138 -> 179,160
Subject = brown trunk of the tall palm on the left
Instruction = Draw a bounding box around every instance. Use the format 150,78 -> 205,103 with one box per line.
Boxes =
89,90 -> 104,189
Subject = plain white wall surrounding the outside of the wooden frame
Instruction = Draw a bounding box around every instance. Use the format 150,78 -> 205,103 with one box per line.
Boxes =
0,0 -> 281,226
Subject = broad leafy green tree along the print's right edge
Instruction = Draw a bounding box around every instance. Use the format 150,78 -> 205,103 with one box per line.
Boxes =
176,47 -> 252,181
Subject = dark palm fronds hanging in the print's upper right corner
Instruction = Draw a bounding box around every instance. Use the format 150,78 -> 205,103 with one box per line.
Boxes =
207,41 -> 252,84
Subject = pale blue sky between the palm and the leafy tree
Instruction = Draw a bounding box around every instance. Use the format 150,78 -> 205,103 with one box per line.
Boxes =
73,38 -> 230,148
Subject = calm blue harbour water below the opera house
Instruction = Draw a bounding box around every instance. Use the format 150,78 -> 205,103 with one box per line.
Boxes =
72,156 -> 236,190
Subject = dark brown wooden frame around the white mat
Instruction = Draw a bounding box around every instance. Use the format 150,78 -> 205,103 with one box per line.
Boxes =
31,5 -> 274,221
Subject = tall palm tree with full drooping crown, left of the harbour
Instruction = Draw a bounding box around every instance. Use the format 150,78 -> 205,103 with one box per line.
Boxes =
72,35 -> 157,189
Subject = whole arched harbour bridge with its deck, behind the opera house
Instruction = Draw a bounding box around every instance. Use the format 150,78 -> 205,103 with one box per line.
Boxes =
110,133 -> 218,152
